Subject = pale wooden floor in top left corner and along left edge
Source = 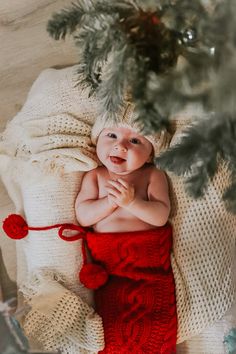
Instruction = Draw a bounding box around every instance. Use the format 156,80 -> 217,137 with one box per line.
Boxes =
0,0 -> 76,288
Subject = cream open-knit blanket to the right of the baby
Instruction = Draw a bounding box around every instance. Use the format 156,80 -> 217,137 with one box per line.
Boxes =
169,121 -> 236,342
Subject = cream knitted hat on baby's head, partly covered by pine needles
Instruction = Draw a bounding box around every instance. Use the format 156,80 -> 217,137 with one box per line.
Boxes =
91,102 -> 170,157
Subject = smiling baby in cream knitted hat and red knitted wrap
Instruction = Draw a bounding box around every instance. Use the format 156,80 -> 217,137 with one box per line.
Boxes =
76,104 -> 177,354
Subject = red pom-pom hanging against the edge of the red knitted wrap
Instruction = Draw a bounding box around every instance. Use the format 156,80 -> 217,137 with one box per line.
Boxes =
79,263 -> 108,289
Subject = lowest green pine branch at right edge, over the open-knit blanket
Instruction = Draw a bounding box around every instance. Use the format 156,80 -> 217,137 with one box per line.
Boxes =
155,113 -> 236,212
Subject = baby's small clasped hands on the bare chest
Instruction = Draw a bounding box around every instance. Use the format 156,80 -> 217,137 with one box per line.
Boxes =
107,178 -> 135,208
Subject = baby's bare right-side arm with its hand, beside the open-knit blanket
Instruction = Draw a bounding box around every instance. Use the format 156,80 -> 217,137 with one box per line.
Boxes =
109,168 -> 170,226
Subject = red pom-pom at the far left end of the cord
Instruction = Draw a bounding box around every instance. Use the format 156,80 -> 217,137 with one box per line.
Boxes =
2,214 -> 28,240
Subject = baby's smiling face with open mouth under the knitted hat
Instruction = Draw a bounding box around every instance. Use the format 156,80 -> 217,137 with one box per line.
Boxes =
97,127 -> 153,175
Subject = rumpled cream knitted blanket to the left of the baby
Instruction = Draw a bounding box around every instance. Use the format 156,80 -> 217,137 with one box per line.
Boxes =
0,69 -> 104,354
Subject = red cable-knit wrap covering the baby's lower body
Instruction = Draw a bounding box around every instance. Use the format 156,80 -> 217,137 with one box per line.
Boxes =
87,225 -> 177,354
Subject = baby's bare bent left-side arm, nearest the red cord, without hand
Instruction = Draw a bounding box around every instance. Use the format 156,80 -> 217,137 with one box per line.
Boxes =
75,169 -> 117,226
